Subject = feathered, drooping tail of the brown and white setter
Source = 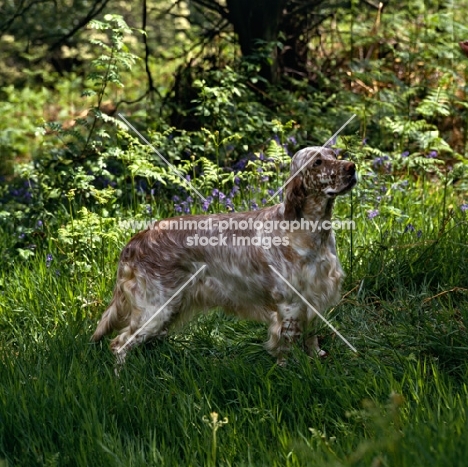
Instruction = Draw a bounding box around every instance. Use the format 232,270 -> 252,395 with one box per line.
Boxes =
91,264 -> 136,342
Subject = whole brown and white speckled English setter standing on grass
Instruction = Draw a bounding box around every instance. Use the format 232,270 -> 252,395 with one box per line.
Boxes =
92,147 -> 356,363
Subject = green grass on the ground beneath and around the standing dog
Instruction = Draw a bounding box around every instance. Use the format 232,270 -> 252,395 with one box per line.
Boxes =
0,174 -> 468,466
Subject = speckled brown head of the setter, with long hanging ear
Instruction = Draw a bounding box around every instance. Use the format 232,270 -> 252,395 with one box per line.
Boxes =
284,146 -> 357,219
